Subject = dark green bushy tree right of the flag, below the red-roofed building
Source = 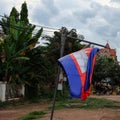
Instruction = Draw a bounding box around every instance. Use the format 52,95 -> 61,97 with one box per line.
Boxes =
93,56 -> 120,85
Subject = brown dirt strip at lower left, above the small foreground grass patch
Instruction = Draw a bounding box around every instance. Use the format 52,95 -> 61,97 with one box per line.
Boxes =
0,103 -> 49,120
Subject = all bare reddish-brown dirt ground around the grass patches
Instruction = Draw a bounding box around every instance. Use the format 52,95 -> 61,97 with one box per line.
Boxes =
0,96 -> 120,120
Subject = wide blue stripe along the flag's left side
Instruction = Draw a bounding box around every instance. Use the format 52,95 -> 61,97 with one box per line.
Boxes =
58,55 -> 82,98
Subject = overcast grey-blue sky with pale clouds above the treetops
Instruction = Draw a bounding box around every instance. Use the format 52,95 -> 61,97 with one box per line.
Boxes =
0,0 -> 120,61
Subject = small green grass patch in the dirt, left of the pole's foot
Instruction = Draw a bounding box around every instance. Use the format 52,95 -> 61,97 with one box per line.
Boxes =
18,111 -> 46,120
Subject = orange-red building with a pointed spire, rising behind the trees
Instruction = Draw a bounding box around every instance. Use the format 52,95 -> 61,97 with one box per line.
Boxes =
98,43 -> 117,61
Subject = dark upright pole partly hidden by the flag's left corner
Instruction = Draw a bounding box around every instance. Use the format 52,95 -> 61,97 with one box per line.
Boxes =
50,27 -> 66,120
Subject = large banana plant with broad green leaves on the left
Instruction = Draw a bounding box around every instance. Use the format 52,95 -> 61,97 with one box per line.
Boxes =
0,16 -> 43,82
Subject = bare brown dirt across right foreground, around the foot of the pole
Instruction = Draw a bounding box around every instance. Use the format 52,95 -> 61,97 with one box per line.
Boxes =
38,109 -> 120,120
